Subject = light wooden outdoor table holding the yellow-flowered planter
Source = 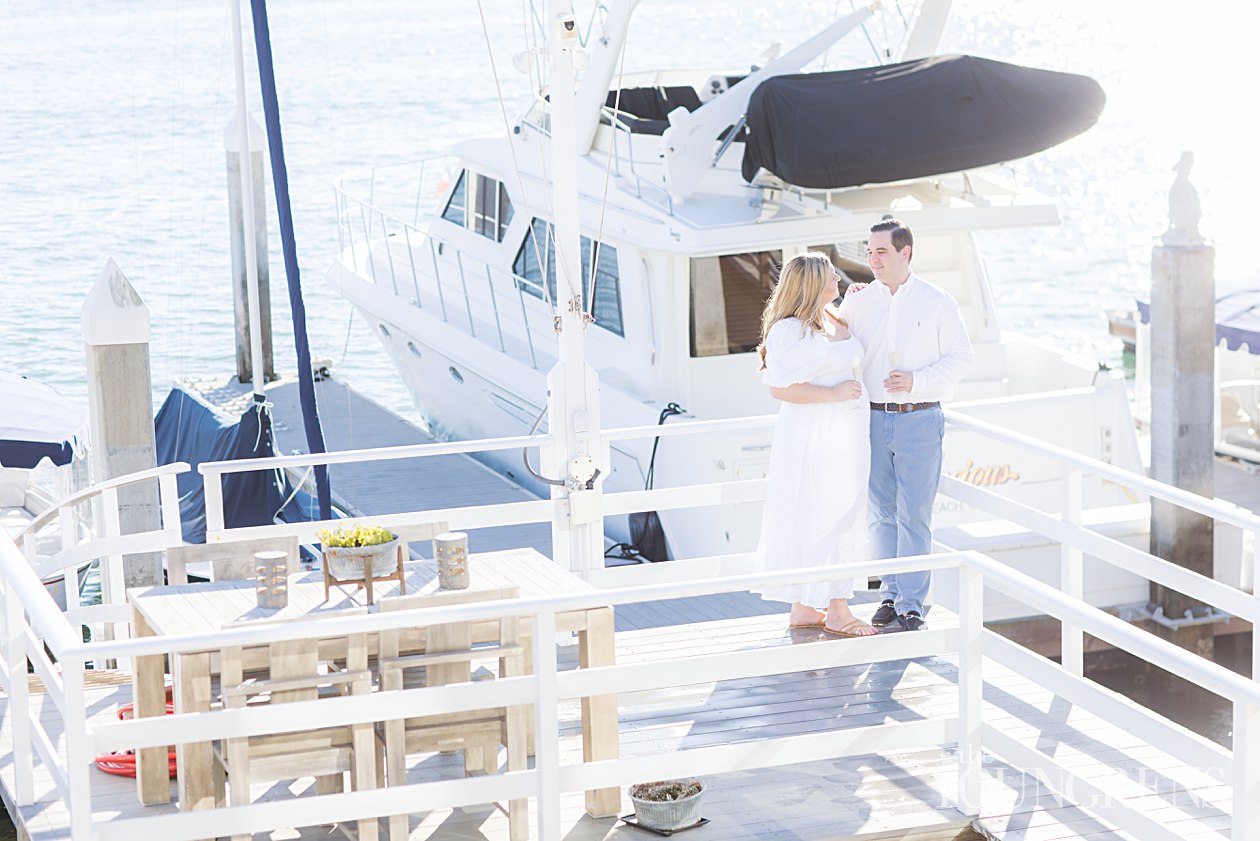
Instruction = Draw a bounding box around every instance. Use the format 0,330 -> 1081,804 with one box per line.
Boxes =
127,548 -> 621,817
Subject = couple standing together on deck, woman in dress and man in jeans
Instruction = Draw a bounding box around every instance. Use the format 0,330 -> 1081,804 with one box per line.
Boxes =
757,219 -> 975,637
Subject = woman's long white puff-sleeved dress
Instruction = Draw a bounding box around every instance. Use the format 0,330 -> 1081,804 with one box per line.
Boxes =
757,318 -> 871,610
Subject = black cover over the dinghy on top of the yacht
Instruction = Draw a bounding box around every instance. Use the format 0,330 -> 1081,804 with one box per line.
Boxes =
742,55 -> 1106,189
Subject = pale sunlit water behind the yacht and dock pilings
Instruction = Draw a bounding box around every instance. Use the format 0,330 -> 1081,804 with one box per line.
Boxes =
0,0 -> 1260,827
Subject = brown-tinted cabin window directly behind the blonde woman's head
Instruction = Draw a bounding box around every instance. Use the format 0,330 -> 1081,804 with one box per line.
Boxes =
690,251 -> 782,357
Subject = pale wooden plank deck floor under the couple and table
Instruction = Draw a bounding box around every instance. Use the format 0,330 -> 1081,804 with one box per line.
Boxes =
0,605 -> 1230,841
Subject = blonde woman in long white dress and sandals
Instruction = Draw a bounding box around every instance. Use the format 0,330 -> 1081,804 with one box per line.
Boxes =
757,251 -> 876,637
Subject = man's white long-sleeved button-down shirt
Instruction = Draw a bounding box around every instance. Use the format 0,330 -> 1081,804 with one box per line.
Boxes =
840,274 -> 975,403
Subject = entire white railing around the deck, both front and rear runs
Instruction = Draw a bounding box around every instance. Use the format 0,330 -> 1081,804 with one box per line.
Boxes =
7,412 -> 1260,841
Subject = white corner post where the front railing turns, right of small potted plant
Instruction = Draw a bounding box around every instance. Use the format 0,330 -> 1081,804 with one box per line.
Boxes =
958,559 -> 984,817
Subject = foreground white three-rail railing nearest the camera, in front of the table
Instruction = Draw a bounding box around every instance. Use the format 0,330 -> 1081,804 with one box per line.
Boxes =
0,522 -> 1260,841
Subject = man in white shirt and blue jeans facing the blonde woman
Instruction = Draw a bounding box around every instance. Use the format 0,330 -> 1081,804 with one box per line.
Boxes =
840,219 -> 975,630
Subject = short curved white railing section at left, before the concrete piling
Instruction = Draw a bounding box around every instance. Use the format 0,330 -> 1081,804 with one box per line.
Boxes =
14,461 -> 189,615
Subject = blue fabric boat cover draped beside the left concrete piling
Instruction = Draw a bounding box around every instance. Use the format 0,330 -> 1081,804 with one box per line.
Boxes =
154,387 -> 292,543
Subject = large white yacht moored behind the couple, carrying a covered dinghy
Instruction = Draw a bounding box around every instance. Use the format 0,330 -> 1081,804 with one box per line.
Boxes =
329,3 -> 1147,617
